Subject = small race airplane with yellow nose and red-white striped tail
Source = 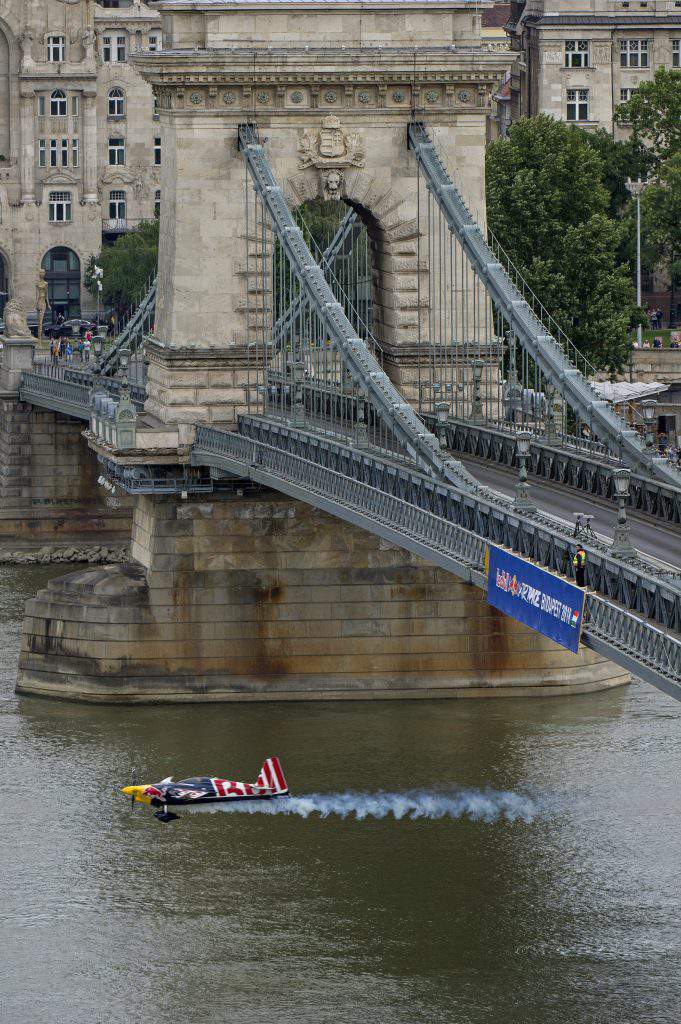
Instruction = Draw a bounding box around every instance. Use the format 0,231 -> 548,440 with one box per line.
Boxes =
121,758 -> 289,821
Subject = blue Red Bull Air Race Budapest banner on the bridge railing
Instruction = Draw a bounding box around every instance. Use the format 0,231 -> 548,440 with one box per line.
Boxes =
487,544 -> 585,653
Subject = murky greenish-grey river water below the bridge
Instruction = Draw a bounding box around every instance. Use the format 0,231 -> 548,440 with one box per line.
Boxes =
0,566 -> 681,1024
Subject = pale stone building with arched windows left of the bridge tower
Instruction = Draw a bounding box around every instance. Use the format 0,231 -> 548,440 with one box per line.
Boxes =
0,0 -> 163,316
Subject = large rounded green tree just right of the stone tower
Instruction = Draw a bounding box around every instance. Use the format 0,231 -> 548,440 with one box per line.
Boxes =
486,115 -> 638,370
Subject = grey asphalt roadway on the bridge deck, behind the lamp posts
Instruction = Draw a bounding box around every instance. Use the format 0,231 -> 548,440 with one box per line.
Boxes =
453,453 -> 681,571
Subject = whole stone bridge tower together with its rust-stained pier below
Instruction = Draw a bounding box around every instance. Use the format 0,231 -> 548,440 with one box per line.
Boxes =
17,0 -> 626,701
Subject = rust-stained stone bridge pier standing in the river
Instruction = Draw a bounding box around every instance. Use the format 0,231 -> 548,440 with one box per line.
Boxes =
17,496 -> 628,701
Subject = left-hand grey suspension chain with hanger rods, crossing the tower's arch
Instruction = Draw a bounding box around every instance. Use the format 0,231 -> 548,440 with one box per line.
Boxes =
239,125 -> 475,487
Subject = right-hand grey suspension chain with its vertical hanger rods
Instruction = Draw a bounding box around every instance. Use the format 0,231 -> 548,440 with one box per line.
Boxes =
409,122 -> 681,487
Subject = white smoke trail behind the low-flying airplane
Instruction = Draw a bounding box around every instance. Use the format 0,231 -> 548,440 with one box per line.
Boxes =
183,790 -> 543,824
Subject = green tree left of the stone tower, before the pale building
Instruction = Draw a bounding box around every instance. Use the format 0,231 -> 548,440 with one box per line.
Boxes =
84,219 -> 159,313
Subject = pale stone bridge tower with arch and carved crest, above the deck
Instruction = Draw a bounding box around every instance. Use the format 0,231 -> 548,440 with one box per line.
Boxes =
135,0 -> 509,443
